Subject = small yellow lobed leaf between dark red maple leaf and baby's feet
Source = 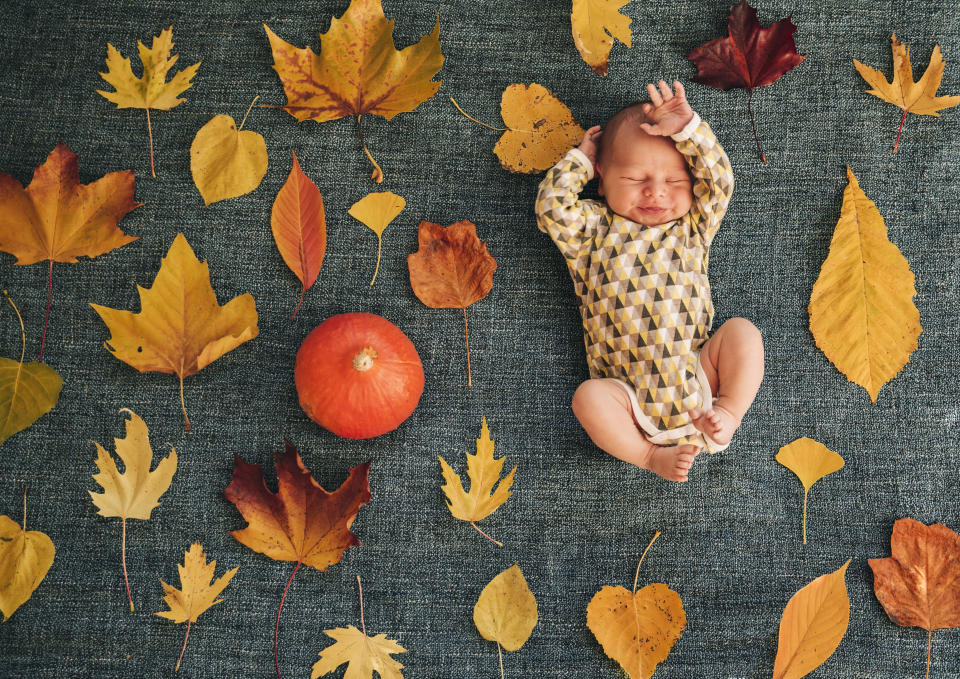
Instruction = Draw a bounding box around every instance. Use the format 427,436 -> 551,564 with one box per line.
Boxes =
437,417 -> 517,547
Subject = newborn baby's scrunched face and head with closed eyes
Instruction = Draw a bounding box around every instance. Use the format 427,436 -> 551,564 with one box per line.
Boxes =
596,129 -> 693,226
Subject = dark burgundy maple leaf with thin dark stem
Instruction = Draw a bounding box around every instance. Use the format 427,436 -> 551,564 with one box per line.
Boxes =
687,0 -> 807,162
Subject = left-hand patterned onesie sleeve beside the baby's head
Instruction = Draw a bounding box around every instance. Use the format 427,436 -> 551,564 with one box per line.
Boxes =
536,149 -> 599,259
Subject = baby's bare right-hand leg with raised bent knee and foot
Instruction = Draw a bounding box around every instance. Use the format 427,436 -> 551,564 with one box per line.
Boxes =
690,318 -> 763,445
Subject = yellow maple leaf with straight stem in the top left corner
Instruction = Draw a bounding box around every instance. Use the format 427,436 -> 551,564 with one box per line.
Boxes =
97,26 -> 200,177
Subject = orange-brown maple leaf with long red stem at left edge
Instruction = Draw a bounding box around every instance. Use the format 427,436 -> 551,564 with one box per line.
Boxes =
0,142 -> 141,361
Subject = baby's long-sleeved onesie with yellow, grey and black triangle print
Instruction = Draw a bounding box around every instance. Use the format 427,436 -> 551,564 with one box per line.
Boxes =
536,113 -> 733,452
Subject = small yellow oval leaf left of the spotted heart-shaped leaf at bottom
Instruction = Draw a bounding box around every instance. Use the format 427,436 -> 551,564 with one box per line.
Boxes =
473,564 -> 537,651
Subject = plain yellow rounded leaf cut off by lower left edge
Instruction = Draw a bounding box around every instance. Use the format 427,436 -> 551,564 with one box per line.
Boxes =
0,516 -> 56,622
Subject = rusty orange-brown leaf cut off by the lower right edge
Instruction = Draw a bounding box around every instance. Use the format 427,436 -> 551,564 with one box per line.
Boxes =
868,518 -> 960,676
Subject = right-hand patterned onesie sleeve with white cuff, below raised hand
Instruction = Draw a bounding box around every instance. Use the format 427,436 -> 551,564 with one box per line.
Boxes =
673,113 -> 733,245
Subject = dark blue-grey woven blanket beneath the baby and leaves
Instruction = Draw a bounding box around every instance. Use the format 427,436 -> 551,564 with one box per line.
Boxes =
0,0 -> 960,679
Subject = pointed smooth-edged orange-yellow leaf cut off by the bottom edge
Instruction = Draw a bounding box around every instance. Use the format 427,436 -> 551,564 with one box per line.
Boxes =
773,559 -> 850,679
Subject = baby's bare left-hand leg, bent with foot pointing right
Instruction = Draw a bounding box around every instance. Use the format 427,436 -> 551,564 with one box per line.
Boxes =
573,379 -> 700,481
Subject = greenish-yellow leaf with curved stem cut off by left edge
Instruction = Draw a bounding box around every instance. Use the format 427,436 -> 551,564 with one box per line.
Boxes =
0,290 -> 63,444
